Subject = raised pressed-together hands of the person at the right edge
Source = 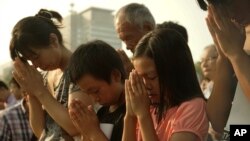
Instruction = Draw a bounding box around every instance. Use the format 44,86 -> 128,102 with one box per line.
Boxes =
206,5 -> 245,57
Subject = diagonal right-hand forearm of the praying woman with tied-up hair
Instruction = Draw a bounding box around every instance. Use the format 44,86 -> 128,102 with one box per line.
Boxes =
37,89 -> 78,136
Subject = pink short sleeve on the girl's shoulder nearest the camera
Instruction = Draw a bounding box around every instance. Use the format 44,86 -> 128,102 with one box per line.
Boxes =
172,98 -> 209,141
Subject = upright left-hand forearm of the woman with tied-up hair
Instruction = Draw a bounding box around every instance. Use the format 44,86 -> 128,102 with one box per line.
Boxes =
29,96 -> 45,138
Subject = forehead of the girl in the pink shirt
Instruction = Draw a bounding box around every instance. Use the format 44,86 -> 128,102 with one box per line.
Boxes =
133,57 -> 156,74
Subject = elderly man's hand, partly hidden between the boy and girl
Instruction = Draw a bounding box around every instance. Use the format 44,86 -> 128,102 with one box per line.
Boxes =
117,49 -> 134,75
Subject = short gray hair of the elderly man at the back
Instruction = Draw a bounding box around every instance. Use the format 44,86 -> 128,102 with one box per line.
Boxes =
114,3 -> 155,28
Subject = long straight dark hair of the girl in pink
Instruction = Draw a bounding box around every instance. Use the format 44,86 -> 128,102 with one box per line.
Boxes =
133,29 -> 204,121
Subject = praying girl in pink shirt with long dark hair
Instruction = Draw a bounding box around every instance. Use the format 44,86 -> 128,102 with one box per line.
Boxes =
122,29 -> 208,141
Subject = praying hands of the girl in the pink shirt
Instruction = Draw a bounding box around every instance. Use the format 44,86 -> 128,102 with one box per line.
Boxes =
126,70 -> 150,118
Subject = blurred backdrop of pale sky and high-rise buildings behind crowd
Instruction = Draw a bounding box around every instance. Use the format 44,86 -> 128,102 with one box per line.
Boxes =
0,0 -> 212,82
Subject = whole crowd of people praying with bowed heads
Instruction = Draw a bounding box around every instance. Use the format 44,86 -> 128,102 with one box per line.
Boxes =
0,0 -> 250,141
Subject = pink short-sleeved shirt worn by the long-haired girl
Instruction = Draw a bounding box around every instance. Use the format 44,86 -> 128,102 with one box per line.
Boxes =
137,98 -> 208,141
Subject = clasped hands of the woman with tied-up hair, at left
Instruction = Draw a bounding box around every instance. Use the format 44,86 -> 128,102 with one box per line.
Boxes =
13,57 -> 48,97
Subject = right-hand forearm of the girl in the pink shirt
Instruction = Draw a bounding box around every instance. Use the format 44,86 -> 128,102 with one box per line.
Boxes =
138,113 -> 159,141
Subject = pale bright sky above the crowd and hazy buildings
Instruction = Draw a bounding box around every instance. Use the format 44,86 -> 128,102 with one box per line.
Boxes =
0,0 -> 213,66
